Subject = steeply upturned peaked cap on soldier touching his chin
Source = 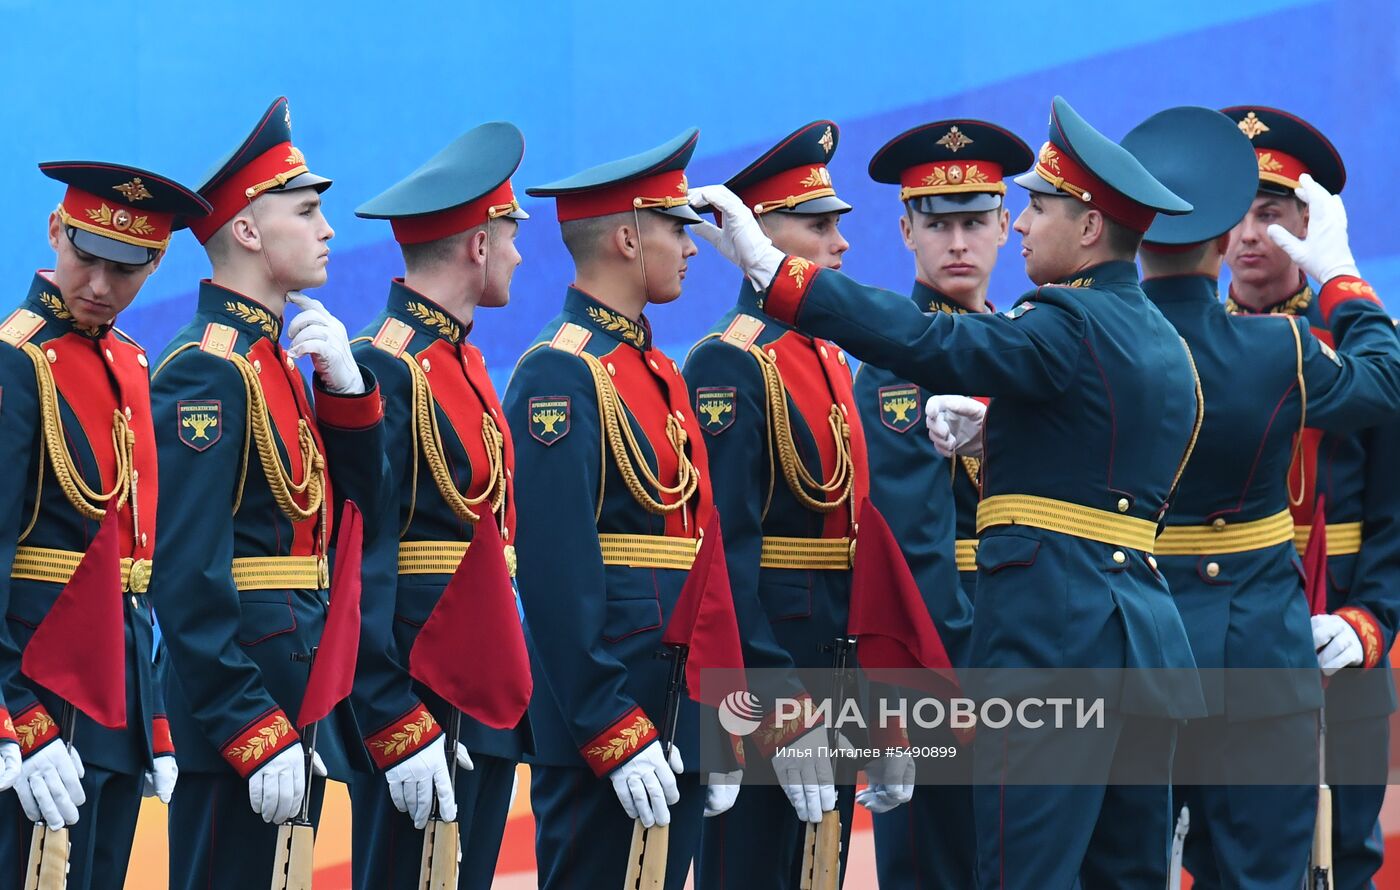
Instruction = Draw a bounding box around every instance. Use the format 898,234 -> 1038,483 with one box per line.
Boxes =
189,97 -> 330,243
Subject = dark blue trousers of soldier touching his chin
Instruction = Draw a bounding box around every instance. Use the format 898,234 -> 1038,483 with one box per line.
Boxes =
168,770 -> 326,890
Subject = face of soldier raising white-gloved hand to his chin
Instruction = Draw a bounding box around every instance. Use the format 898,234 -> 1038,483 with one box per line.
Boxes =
252,189 -> 336,291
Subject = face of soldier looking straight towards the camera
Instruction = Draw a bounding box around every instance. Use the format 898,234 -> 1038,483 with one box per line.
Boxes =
899,209 -> 1011,298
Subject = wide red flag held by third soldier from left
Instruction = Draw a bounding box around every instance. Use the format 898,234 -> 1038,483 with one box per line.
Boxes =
409,512 -> 533,729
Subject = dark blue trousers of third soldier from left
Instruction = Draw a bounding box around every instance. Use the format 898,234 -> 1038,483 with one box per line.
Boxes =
350,754 -> 515,890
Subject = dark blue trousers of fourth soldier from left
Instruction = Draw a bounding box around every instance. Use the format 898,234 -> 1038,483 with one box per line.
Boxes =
529,765 -> 705,890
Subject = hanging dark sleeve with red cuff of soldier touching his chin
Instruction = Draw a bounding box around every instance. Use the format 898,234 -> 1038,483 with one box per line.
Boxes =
150,350 -> 298,778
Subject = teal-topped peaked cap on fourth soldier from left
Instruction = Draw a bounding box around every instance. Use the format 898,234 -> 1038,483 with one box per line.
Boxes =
525,127 -> 700,223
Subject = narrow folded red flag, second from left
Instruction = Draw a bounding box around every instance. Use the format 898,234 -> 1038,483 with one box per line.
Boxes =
297,501 -> 364,726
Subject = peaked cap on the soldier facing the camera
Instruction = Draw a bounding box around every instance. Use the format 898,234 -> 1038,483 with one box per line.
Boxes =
869,119 -> 1036,213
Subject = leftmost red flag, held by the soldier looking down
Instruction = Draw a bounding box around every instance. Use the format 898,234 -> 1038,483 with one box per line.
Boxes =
20,508 -> 126,729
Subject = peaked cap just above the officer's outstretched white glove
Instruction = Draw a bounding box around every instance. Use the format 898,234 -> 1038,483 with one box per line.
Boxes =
724,120 -> 851,214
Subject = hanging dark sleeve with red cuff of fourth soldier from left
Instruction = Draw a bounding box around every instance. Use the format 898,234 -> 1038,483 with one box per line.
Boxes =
504,348 -> 661,777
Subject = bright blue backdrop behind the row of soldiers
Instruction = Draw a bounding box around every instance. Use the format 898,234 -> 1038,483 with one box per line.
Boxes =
0,0 -> 1400,385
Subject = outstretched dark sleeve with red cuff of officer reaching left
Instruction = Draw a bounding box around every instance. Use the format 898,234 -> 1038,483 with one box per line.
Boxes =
764,256 -> 1086,400
